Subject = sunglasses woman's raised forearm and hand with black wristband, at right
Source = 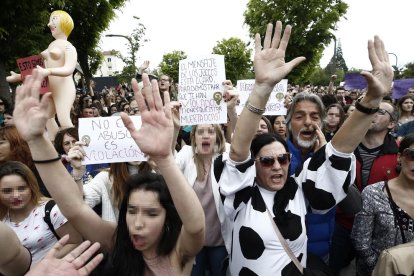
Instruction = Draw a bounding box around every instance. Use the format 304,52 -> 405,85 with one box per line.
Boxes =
332,36 -> 394,153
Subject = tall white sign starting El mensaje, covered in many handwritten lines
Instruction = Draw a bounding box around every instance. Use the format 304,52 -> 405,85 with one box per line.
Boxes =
178,55 -> 227,126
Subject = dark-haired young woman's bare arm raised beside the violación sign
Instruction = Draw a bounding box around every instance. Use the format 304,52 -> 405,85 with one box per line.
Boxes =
121,73 -> 205,261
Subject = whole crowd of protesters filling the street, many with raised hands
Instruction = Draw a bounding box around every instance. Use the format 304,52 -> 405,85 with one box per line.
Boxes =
0,19 -> 414,276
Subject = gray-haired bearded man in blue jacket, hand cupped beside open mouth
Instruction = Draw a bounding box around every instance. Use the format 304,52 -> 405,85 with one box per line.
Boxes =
286,92 -> 335,262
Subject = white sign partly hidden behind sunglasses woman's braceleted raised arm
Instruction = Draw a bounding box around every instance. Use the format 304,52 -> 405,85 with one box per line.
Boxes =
236,79 -> 288,115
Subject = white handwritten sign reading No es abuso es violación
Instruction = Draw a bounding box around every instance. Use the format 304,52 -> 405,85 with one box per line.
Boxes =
79,116 -> 147,165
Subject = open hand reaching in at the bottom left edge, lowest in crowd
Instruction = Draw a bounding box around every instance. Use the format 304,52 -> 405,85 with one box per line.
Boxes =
26,235 -> 103,276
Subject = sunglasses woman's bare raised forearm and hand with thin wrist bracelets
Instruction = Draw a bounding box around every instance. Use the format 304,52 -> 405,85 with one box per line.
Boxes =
230,21 -> 305,161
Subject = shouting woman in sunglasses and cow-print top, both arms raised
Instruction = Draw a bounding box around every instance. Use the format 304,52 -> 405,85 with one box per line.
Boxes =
214,21 -> 393,275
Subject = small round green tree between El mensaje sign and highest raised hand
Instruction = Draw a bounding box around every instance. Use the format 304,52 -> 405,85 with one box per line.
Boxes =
213,37 -> 252,84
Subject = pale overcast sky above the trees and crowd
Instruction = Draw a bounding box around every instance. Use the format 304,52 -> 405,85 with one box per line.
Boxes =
100,0 -> 414,73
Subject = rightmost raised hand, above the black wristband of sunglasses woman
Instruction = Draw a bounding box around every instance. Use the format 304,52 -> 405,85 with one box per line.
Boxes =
361,36 -> 394,103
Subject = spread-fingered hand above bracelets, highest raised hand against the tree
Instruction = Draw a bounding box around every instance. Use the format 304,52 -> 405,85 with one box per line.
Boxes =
254,21 -> 305,94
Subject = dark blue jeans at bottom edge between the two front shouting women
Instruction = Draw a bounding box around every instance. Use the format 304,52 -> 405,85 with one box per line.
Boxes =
191,245 -> 228,276
